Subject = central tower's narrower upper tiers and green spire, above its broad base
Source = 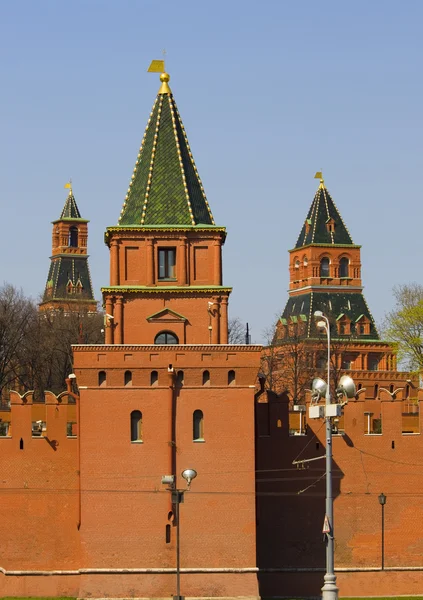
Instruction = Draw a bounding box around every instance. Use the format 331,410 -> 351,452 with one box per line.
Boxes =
102,68 -> 231,344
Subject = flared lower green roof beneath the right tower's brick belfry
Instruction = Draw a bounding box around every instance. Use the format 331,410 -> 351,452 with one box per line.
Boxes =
281,292 -> 380,341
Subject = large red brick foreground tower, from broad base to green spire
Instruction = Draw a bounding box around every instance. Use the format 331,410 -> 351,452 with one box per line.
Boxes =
74,68 -> 261,598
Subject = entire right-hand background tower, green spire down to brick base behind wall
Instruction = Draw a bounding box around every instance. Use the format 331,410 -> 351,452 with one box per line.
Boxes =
274,173 -> 402,399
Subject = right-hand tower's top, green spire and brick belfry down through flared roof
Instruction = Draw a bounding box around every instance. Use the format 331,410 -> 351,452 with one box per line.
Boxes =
279,173 -> 379,340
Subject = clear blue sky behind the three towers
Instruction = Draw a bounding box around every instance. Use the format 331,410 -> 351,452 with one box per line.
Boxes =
0,0 -> 423,342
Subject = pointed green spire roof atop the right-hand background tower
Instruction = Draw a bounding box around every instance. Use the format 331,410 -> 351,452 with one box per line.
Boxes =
295,183 -> 354,248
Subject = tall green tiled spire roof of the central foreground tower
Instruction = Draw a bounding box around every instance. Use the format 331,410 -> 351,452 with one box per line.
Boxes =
118,75 -> 214,226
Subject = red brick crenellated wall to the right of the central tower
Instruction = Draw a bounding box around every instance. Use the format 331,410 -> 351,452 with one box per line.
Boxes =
256,394 -> 423,596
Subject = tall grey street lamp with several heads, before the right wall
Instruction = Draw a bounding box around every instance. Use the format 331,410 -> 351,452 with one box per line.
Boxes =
309,310 -> 356,600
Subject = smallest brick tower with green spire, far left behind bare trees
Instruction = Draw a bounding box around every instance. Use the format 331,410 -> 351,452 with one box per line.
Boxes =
40,183 -> 97,312
